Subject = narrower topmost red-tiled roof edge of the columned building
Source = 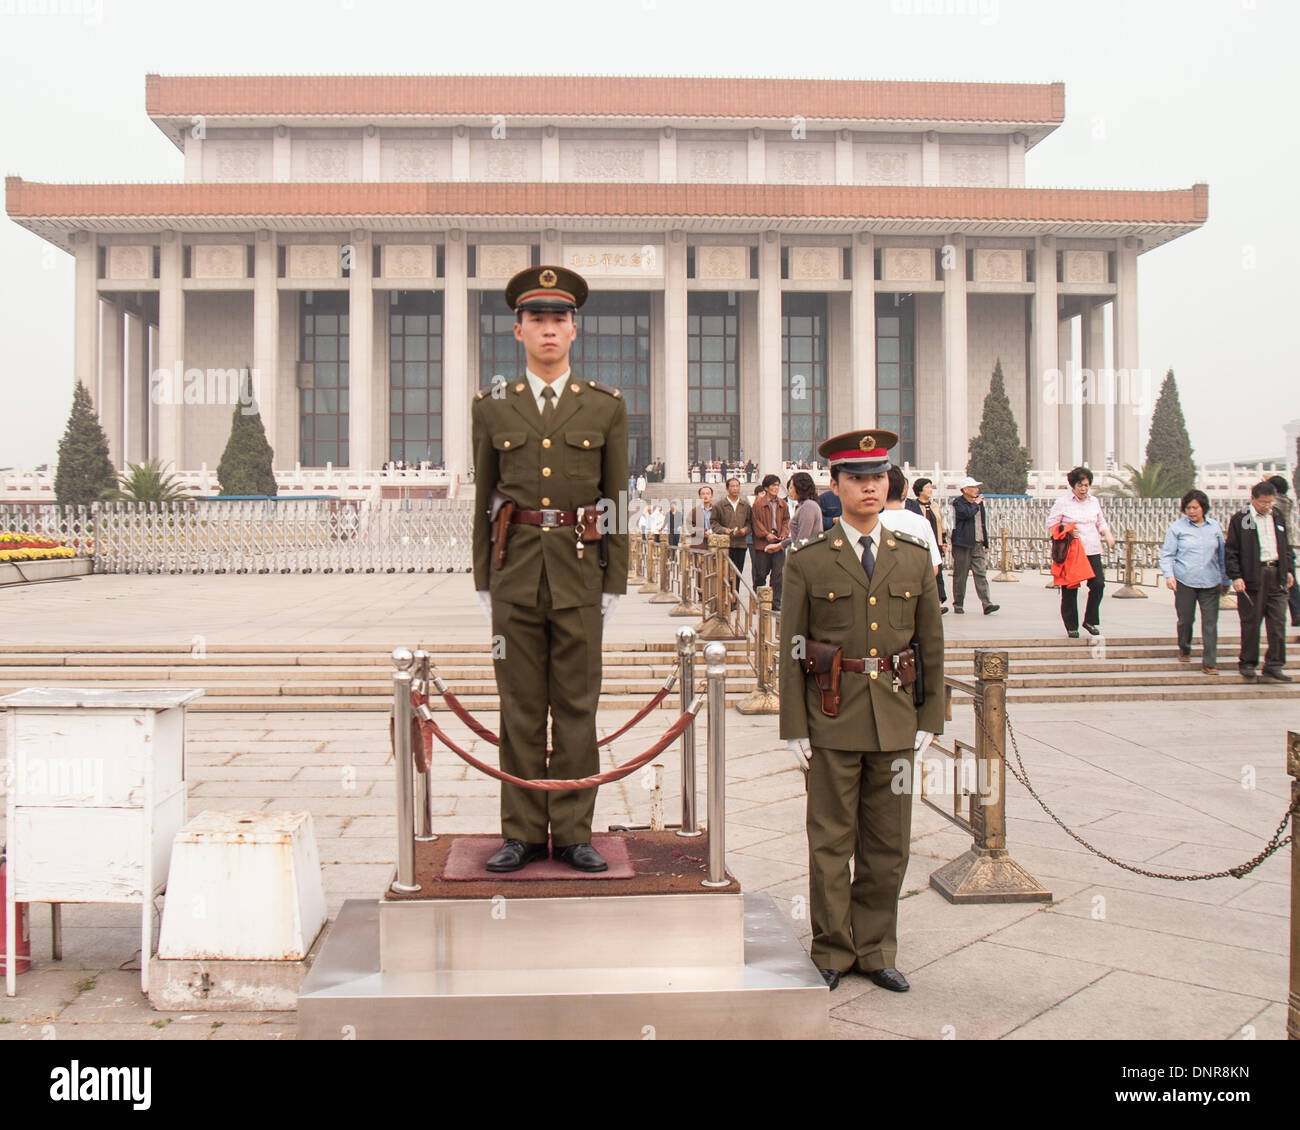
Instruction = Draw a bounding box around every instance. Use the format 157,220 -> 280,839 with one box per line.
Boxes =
144,74 -> 1065,122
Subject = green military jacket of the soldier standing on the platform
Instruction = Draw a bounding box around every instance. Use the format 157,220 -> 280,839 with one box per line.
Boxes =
472,373 -> 628,609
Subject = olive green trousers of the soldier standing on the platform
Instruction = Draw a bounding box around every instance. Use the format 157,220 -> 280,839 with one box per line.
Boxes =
491,573 -> 602,848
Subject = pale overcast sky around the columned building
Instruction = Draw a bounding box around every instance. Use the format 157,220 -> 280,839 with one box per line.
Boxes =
0,0 -> 1300,467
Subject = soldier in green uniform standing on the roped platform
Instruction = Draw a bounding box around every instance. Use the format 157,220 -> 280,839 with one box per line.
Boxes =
473,267 -> 628,871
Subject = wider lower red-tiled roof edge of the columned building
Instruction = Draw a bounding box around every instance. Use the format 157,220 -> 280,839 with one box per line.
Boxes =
5,177 -> 1209,224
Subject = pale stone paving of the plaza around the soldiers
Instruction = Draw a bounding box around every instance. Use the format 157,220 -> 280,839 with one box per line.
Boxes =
0,576 -> 1300,1040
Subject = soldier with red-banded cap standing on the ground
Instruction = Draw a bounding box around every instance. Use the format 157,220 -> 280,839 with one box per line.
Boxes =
780,429 -> 944,992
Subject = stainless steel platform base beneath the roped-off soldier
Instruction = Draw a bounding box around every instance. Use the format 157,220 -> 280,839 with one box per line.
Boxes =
298,893 -> 828,1040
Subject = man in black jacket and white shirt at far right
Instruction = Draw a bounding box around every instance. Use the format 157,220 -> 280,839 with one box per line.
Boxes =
1223,480 -> 1295,683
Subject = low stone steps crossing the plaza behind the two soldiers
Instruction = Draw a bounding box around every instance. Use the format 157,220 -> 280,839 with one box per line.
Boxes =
0,631 -> 1300,714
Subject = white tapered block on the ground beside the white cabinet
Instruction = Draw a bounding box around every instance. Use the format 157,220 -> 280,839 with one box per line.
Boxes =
159,811 -> 325,961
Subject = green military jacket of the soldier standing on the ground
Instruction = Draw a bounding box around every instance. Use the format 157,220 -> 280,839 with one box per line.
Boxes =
780,521 -> 944,750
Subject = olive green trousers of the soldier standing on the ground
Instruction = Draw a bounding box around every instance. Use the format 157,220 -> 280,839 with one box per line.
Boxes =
807,746 -> 914,973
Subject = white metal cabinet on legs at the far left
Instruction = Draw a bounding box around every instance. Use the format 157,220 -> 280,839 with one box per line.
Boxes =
0,687 -> 203,996
